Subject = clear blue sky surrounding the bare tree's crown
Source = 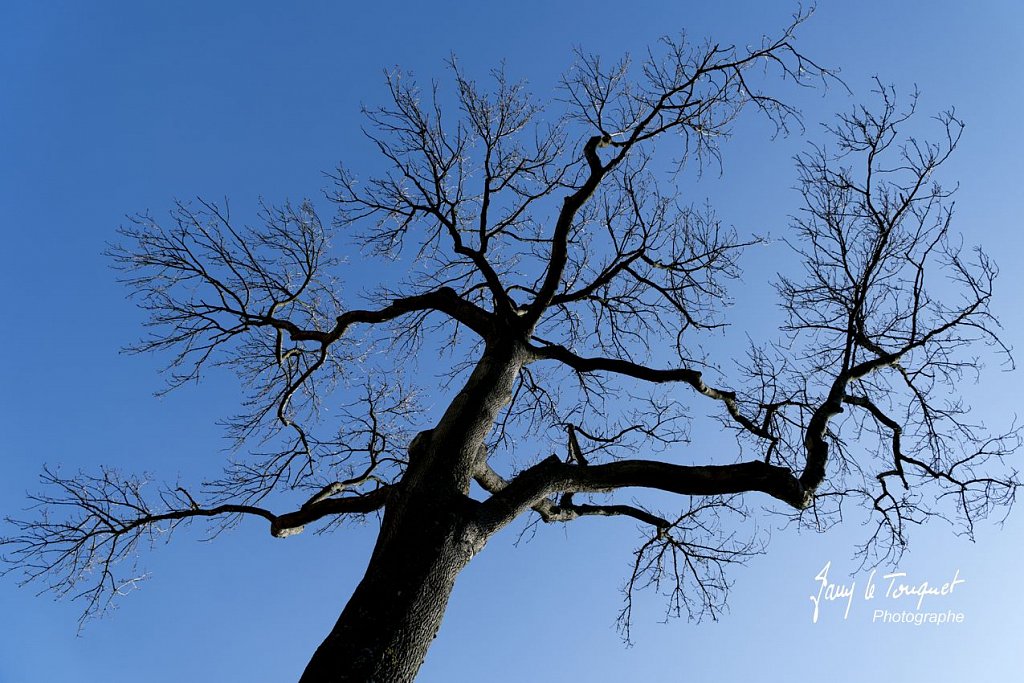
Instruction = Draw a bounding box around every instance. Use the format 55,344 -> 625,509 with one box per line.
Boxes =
0,0 -> 1024,683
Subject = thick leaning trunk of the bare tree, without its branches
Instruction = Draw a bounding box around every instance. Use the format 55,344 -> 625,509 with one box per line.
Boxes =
300,342 -> 525,683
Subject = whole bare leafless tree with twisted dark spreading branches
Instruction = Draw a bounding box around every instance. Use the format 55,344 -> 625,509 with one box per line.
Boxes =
5,12 -> 1018,681
